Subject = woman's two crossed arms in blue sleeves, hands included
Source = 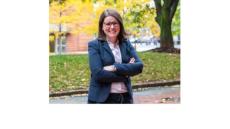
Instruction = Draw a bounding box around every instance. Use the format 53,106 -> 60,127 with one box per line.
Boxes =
88,42 -> 143,82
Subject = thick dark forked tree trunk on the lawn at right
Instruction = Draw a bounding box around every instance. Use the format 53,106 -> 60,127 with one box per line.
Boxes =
154,0 -> 179,51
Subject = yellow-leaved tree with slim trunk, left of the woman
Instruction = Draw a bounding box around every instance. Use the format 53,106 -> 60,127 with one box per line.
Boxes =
49,0 -> 93,54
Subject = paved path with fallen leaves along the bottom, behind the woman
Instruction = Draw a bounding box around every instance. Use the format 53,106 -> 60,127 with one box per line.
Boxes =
50,85 -> 180,104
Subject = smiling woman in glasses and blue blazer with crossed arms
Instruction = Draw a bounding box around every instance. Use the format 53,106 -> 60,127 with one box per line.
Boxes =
88,9 -> 143,103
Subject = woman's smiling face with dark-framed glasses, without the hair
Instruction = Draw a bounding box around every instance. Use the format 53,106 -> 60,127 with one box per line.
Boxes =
103,16 -> 120,39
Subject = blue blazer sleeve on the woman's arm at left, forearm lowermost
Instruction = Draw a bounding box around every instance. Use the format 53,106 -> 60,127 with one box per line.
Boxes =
88,40 -> 126,83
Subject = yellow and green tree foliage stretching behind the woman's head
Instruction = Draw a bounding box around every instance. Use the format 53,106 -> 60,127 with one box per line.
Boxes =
49,0 -> 163,45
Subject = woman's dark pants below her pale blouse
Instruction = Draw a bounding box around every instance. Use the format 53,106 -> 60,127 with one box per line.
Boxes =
88,93 -> 133,104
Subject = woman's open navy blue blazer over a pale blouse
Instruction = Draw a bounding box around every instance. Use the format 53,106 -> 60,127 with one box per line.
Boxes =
88,39 -> 143,103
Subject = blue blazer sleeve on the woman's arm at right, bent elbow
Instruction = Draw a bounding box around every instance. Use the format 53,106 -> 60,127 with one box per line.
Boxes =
114,41 -> 143,76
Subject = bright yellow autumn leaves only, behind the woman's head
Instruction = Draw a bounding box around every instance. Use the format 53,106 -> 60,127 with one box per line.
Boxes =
49,0 -> 160,36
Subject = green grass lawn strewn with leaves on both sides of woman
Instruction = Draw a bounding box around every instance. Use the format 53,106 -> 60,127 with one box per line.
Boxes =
49,52 -> 180,92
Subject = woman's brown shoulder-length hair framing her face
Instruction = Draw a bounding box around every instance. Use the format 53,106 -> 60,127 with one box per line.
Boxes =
98,9 -> 127,43
